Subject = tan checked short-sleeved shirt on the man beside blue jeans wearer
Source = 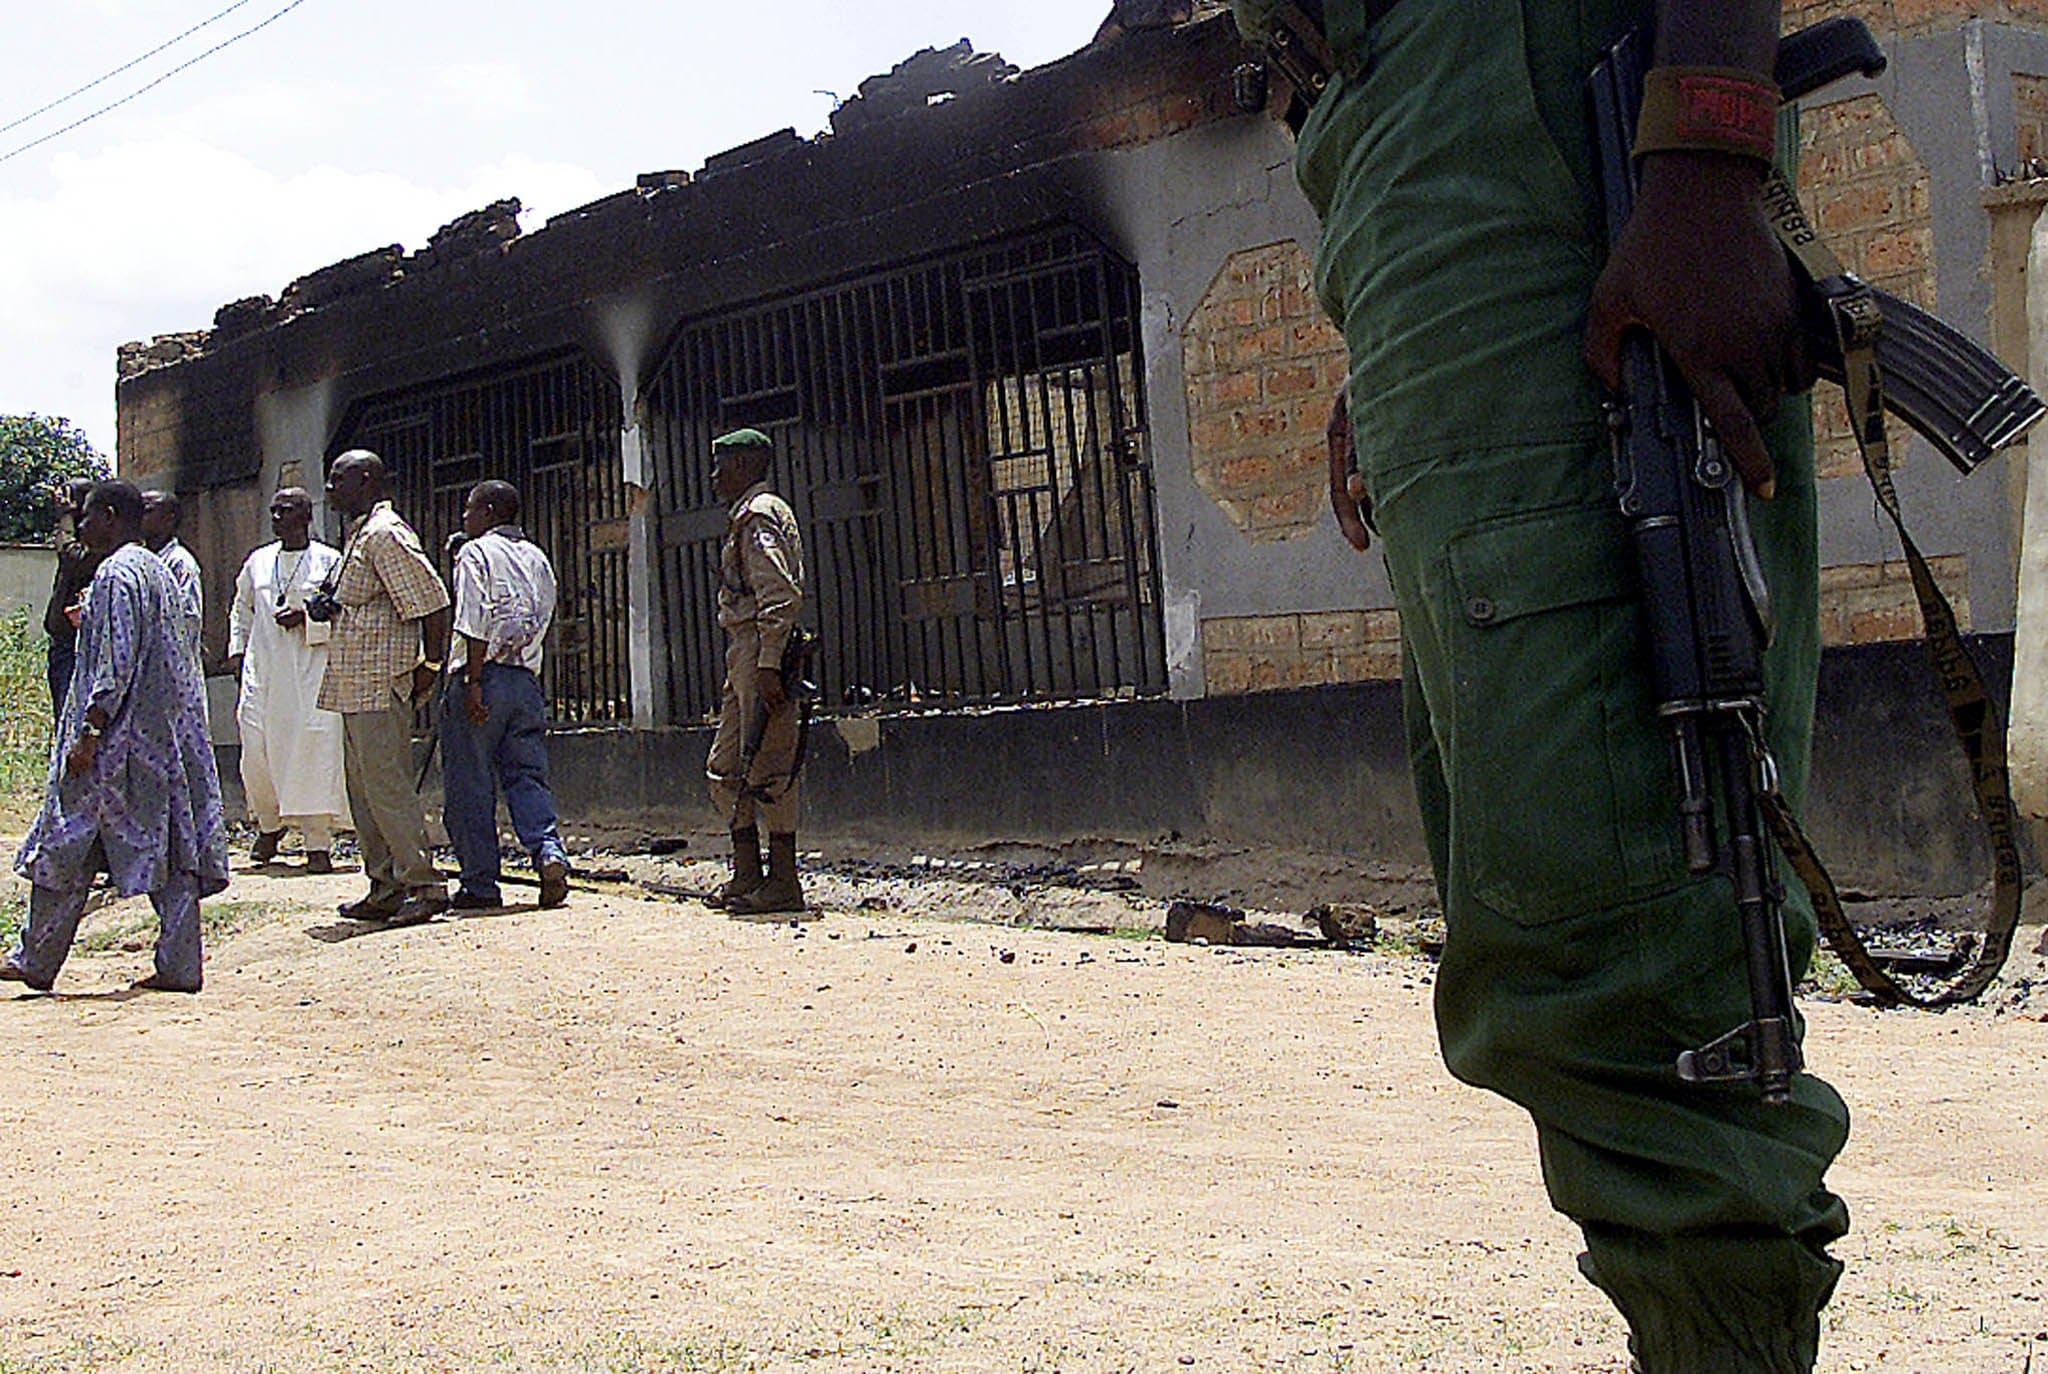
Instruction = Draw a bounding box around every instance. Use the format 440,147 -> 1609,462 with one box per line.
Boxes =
319,502 -> 449,711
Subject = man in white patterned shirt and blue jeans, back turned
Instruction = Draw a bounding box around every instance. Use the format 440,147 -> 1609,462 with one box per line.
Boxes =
440,479 -> 569,911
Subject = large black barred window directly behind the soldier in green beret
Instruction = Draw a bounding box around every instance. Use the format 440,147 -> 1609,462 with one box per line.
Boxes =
645,227 -> 1165,721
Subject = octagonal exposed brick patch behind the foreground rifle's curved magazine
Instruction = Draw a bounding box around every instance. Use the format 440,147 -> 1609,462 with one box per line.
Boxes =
1798,94 -> 1935,477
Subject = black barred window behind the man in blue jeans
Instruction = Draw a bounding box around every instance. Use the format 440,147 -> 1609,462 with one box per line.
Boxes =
328,354 -> 633,725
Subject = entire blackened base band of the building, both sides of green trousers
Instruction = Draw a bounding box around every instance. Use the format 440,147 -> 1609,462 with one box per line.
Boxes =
219,635 -> 2042,897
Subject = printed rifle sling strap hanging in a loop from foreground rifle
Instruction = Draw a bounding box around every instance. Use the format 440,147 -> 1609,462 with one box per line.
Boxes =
1763,172 -> 2023,1007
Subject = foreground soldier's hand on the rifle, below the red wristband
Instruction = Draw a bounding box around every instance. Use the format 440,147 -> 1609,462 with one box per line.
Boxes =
1585,152 -> 1812,498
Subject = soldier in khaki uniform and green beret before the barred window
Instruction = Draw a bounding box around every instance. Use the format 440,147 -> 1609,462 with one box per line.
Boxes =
705,430 -> 803,919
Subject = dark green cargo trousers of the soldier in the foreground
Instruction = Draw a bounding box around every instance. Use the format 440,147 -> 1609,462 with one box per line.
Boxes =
1286,0 -> 1847,1374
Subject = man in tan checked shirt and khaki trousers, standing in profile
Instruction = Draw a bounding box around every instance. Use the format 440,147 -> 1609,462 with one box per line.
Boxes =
319,448 -> 449,926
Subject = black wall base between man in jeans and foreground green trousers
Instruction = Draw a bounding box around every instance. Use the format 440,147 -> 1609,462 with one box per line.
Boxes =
551,682 -> 1427,864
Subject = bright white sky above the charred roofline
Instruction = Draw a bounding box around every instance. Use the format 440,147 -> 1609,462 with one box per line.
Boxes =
0,0 -> 1110,459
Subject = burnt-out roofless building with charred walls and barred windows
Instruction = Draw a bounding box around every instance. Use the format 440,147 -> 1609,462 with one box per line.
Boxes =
119,0 -> 2048,891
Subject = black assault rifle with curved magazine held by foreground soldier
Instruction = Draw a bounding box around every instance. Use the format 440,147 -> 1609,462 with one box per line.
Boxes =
1591,18 -> 2044,1104
